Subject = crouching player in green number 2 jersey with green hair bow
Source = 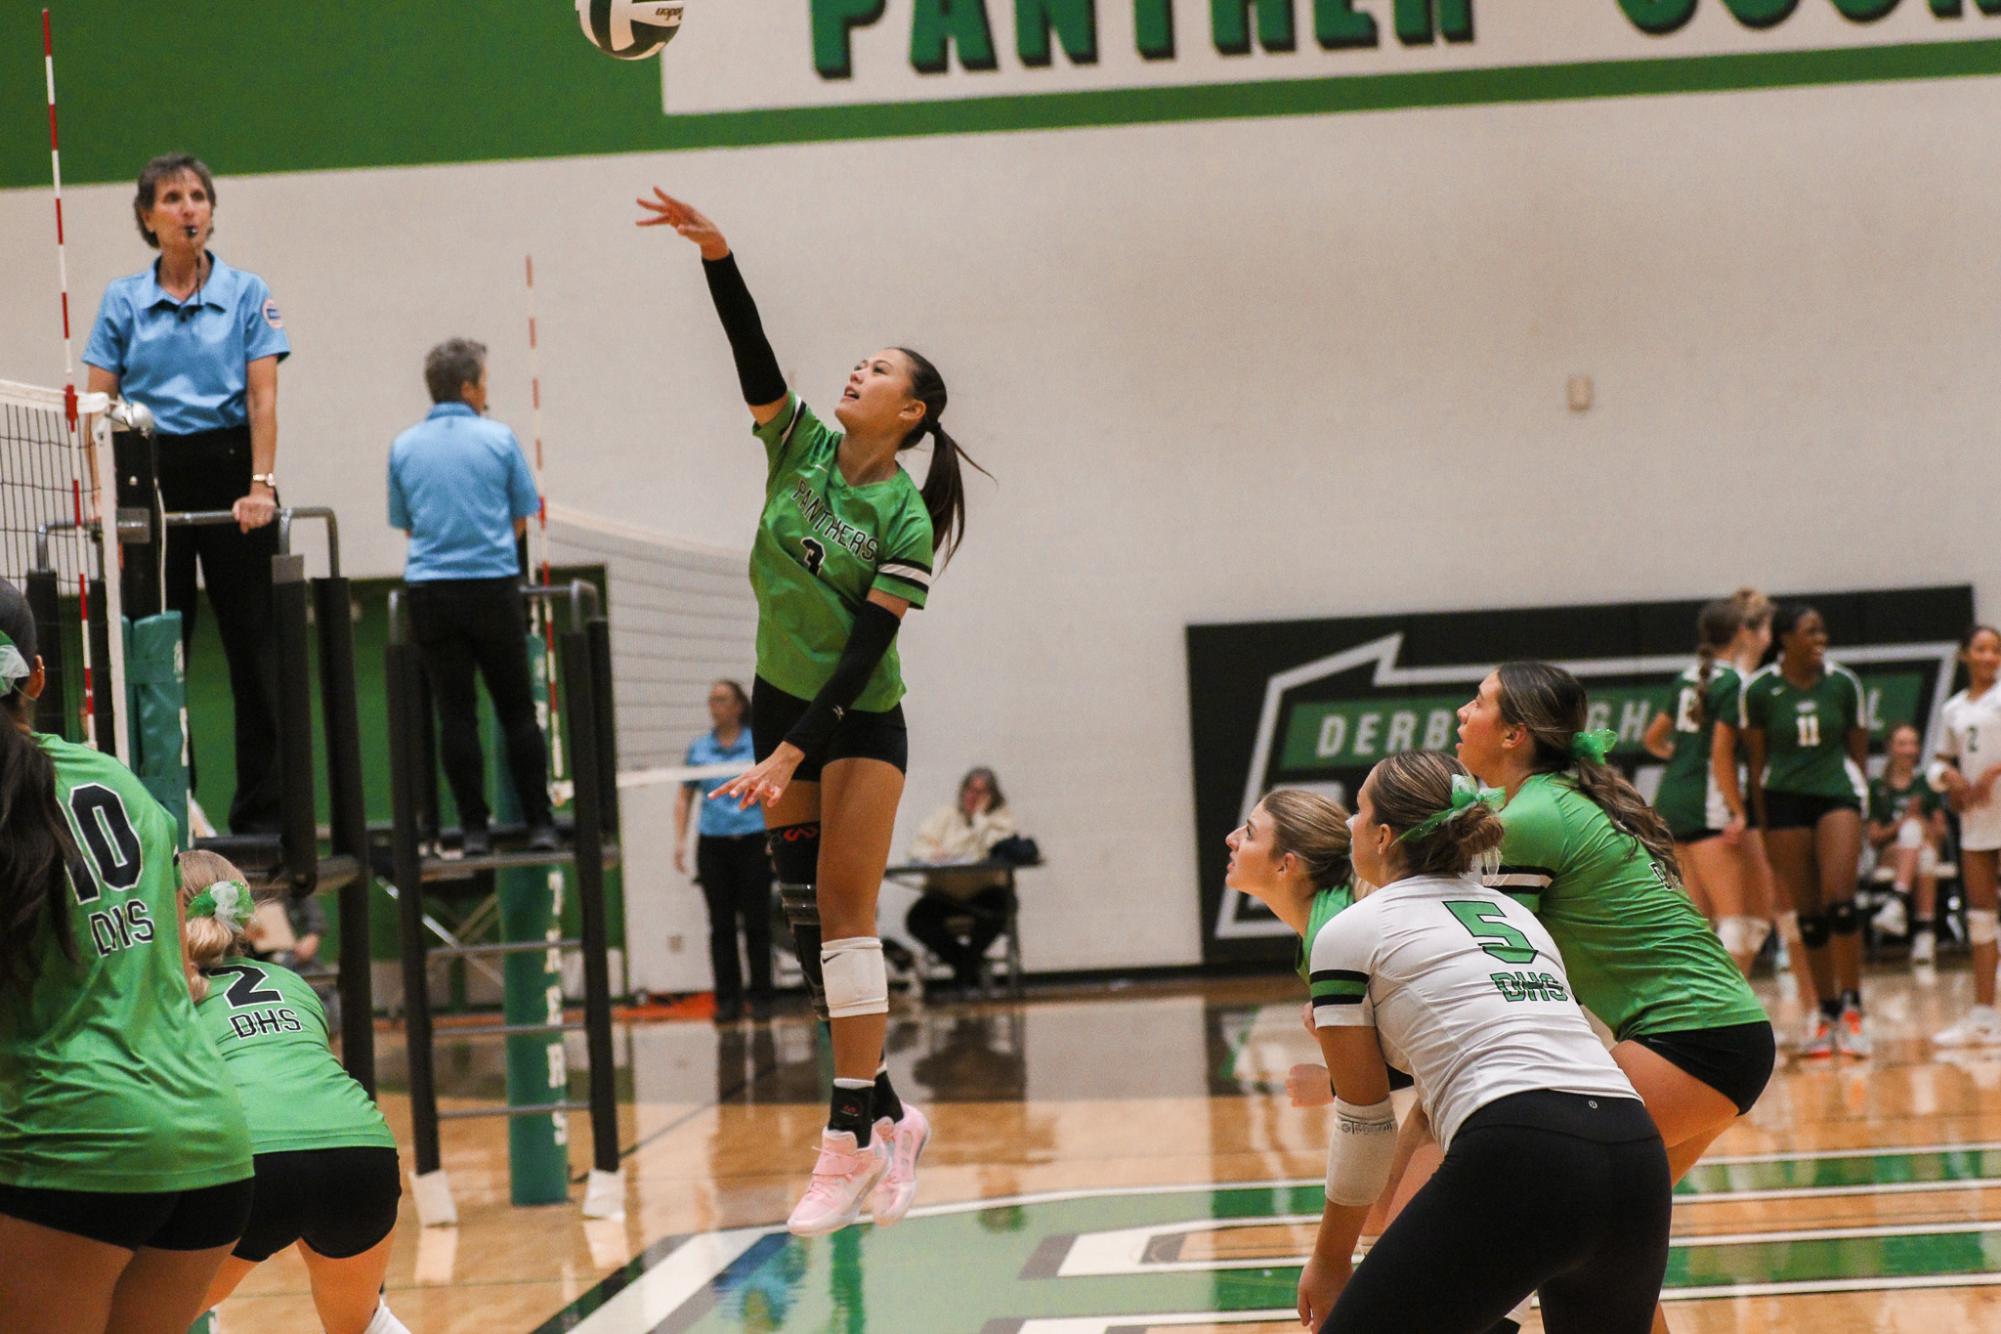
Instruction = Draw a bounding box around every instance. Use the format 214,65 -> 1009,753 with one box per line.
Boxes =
180,850 -> 408,1334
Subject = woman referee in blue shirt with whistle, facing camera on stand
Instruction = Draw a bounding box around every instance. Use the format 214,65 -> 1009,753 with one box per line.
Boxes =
84,154 -> 292,834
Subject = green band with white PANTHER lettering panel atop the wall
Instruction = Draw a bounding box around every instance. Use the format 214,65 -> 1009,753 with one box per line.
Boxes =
0,0 -> 2001,188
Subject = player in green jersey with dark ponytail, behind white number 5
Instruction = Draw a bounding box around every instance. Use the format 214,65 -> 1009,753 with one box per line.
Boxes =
1459,662 -> 1773,1328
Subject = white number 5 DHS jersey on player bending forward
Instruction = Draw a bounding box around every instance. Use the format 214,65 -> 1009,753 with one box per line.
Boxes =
1313,876 -> 1639,1148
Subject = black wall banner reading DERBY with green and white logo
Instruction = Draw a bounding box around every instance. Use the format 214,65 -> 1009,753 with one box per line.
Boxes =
1189,584 -> 1973,962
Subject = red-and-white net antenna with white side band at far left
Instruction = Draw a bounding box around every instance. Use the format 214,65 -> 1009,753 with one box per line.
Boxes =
42,10 -> 132,756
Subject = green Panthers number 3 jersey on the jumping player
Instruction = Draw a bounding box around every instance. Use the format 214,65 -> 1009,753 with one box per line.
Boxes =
750,394 -> 932,712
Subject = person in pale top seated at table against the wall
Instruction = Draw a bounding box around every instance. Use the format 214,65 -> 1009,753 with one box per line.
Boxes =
904,766 -> 1015,990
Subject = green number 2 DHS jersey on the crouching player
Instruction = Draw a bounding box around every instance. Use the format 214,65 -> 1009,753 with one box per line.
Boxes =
198,958 -> 396,1154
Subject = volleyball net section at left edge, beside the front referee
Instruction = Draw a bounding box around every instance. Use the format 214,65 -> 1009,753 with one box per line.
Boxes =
0,380 -> 124,754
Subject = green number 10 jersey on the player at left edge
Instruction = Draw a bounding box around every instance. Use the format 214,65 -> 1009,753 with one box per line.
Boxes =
0,736 -> 250,1194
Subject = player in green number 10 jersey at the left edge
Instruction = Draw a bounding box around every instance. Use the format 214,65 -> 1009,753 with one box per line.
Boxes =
0,580 -> 250,1334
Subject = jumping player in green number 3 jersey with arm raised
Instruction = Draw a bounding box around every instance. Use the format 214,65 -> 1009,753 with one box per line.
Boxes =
638,190 -> 976,1236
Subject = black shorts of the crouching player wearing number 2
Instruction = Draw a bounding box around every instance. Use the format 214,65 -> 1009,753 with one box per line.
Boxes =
236,1148 -> 402,1264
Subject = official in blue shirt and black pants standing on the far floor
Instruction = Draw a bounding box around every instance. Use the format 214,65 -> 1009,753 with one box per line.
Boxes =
674,680 -> 770,1024
